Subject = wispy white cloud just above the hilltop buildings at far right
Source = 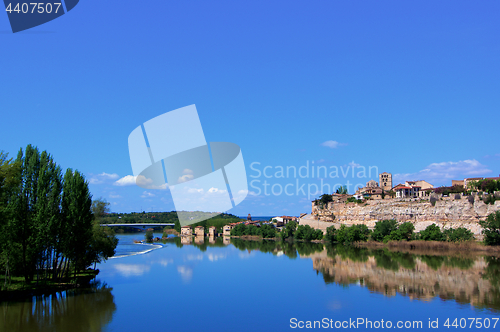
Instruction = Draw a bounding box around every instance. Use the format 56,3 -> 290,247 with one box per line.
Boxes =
394,159 -> 491,185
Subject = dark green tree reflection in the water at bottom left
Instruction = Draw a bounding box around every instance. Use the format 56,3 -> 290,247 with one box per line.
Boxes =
0,283 -> 116,332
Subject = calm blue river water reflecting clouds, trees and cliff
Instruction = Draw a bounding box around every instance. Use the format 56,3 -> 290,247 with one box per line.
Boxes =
0,234 -> 500,331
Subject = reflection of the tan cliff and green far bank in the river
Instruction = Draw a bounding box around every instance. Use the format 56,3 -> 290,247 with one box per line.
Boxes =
161,237 -> 500,310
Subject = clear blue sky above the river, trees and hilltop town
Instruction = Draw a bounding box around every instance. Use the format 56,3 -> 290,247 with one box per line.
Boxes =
0,0 -> 500,215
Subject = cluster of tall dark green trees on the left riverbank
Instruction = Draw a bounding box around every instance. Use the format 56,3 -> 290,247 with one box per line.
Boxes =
0,145 -> 118,283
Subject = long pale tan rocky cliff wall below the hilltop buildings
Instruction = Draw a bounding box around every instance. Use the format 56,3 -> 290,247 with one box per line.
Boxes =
308,195 -> 500,237
